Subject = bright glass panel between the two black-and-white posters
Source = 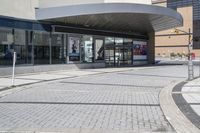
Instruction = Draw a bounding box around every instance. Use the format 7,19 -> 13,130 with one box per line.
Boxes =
81,35 -> 94,62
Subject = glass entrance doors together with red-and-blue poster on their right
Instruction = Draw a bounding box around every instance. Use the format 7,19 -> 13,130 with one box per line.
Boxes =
105,37 -> 147,66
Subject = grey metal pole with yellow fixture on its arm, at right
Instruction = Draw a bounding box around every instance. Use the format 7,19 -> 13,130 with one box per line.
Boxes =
174,28 -> 194,80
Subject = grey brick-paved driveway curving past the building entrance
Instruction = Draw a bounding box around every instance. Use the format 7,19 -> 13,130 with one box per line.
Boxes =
0,66 -> 199,132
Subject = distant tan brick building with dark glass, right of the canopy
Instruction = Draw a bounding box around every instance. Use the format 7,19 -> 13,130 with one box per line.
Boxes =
153,0 -> 200,57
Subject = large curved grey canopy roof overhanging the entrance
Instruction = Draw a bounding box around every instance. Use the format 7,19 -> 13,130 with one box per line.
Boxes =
36,3 -> 183,33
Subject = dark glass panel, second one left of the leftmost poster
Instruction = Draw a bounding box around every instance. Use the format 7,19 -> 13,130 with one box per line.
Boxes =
34,32 -> 50,64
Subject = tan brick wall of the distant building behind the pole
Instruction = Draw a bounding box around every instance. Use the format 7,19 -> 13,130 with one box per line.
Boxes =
154,2 -> 200,57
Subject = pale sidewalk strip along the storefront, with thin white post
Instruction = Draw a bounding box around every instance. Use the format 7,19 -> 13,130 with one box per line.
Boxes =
0,67 -> 150,91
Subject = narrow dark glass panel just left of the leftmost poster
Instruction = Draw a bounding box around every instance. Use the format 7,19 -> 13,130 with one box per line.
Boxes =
51,34 -> 64,64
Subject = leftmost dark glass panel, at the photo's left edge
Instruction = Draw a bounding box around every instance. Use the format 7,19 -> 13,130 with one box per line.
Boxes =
0,28 -> 14,65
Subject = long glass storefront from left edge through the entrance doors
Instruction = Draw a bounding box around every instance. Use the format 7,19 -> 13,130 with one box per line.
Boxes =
0,19 -> 148,67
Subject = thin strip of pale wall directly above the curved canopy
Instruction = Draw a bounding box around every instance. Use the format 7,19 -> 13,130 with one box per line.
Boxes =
39,0 -> 151,8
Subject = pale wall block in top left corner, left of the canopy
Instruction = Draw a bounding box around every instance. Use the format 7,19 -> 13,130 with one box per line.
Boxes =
0,0 -> 38,19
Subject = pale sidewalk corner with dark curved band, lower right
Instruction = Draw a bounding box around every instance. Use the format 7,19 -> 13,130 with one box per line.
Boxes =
171,78 -> 200,133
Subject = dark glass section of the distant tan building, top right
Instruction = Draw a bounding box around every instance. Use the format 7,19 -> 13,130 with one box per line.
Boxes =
167,0 -> 200,49
